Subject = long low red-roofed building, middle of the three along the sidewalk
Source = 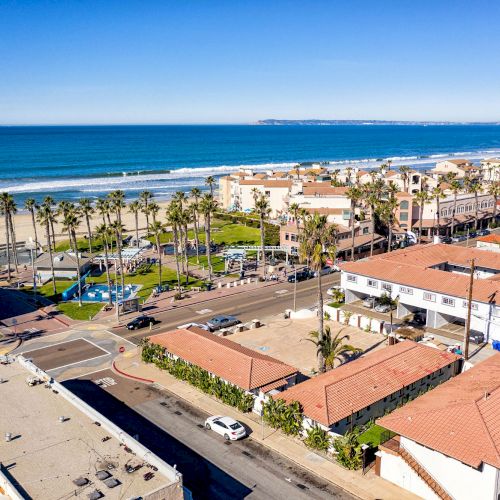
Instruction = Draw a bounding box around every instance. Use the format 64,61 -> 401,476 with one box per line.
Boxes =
273,340 -> 460,436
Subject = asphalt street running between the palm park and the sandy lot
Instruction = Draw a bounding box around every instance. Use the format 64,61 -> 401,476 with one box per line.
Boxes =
113,273 -> 340,343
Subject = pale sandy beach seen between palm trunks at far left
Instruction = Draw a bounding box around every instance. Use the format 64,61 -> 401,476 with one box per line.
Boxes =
0,201 -> 176,245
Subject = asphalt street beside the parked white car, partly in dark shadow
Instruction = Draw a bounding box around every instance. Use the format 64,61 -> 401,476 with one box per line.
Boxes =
64,370 -> 353,500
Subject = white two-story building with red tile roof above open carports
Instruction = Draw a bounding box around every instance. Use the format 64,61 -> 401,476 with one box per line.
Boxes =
341,244 -> 500,342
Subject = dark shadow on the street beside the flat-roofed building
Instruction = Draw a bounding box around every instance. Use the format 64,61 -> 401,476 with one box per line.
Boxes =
63,379 -> 252,499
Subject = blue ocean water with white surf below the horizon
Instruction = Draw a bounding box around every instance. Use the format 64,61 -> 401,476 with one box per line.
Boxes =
0,125 -> 500,204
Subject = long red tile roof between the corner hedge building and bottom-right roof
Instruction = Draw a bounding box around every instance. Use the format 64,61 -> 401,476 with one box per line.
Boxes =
275,340 -> 459,426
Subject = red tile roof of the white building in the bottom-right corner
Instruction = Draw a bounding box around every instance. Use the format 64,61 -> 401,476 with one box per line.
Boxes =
377,354 -> 500,468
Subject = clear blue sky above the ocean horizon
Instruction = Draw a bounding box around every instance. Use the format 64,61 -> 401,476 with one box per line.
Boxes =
0,0 -> 500,124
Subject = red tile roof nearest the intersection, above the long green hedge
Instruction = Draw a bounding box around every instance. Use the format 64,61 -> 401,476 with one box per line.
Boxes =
149,327 -> 298,390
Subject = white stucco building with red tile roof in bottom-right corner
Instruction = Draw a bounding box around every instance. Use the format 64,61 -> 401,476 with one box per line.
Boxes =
375,354 -> 500,500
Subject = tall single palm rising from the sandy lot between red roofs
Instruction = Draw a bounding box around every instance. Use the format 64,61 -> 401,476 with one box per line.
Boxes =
299,213 -> 335,372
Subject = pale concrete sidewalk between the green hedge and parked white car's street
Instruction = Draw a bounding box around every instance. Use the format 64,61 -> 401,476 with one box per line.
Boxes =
113,348 -> 417,500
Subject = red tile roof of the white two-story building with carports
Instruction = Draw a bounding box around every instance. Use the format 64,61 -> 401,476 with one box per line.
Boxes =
342,244 -> 500,303
